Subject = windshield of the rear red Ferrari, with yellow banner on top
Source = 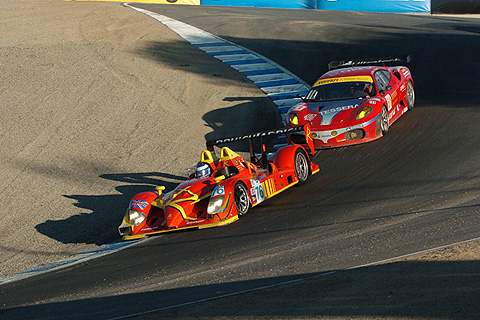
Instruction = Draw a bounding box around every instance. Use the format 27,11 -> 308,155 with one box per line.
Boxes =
305,77 -> 375,101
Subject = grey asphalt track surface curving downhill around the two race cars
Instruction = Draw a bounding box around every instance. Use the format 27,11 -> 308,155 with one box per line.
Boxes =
0,5 -> 480,319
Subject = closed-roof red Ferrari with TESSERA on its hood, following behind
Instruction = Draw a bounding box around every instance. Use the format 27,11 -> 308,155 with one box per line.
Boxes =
285,56 -> 415,149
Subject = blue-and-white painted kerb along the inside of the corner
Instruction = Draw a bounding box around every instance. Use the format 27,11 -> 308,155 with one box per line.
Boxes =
0,3 -> 310,285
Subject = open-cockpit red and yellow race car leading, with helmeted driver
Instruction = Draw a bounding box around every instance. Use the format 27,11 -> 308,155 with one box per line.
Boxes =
118,125 -> 319,240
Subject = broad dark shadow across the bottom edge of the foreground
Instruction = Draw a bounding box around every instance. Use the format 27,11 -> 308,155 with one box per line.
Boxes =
0,260 -> 480,319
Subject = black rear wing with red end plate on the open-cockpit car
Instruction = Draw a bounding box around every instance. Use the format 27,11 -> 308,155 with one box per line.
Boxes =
207,123 -> 315,165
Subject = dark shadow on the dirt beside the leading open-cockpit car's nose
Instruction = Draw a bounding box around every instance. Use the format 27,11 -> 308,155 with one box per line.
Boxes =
35,172 -> 186,245
